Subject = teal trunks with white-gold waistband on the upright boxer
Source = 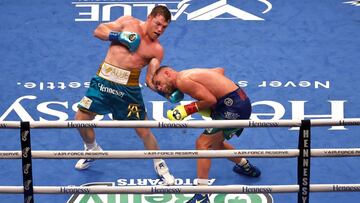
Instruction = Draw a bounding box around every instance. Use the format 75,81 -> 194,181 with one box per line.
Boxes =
78,62 -> 145,120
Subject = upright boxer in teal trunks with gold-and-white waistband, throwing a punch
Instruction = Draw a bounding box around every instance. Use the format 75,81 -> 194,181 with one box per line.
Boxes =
75,5 -> 181,185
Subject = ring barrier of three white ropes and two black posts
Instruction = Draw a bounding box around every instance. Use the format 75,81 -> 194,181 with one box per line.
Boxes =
0,118 -> 360,203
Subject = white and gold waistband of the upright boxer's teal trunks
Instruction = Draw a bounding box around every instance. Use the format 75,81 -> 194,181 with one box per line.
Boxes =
97,62 -> 141,86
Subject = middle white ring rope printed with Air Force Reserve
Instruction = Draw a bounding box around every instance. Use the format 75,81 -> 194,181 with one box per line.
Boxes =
0,148 -> 360,159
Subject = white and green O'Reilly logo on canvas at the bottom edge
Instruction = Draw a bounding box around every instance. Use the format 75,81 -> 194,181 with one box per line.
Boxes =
67,180 -> 274,203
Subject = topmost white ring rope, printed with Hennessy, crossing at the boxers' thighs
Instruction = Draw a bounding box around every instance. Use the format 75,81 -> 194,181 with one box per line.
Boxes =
0,118 -> 360,128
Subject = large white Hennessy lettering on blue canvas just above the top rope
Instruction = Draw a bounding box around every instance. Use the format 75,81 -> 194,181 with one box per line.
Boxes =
0,95 -> 351,130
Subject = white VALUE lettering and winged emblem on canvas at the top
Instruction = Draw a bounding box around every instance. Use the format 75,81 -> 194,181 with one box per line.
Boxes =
72,0 -> 272,22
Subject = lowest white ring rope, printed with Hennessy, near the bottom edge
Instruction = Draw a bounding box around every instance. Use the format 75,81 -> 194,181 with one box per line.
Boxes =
0,184 -> 360,194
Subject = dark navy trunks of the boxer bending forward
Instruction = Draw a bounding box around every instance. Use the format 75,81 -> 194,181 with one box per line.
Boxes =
203,87 -> 251,140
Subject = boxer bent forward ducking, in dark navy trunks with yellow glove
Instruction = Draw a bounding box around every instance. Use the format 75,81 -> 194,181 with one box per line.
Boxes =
153,66 -> 261,203
